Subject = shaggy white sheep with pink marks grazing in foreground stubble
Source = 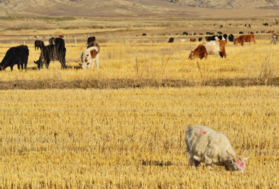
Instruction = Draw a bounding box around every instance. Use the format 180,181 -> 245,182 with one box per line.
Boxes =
185,125 -> 249,173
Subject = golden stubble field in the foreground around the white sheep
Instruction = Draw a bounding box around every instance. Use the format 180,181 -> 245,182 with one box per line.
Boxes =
0,87 -> 279,189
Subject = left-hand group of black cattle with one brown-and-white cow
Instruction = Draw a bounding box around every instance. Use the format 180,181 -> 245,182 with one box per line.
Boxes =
0,36 -> 100,70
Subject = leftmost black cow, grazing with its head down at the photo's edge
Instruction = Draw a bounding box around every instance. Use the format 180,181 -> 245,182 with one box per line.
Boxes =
0,45 -> 29,71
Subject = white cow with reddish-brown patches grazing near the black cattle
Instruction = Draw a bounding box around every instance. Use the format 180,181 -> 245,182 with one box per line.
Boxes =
80,47 -> 99,69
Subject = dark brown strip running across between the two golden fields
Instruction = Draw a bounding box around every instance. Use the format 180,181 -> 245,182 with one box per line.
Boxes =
0,78 -> 279,90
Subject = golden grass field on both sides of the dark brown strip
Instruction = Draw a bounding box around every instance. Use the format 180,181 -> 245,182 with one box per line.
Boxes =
0,36 -> 279,189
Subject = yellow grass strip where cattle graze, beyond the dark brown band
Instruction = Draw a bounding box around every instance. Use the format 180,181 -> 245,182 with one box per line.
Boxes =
0,40 -> 279,84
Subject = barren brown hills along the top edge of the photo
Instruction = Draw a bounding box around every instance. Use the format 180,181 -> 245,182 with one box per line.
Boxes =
0,0 -> 279,17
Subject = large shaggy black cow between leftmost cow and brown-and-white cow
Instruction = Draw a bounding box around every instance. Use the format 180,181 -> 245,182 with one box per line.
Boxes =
34,44 -> 67,69
